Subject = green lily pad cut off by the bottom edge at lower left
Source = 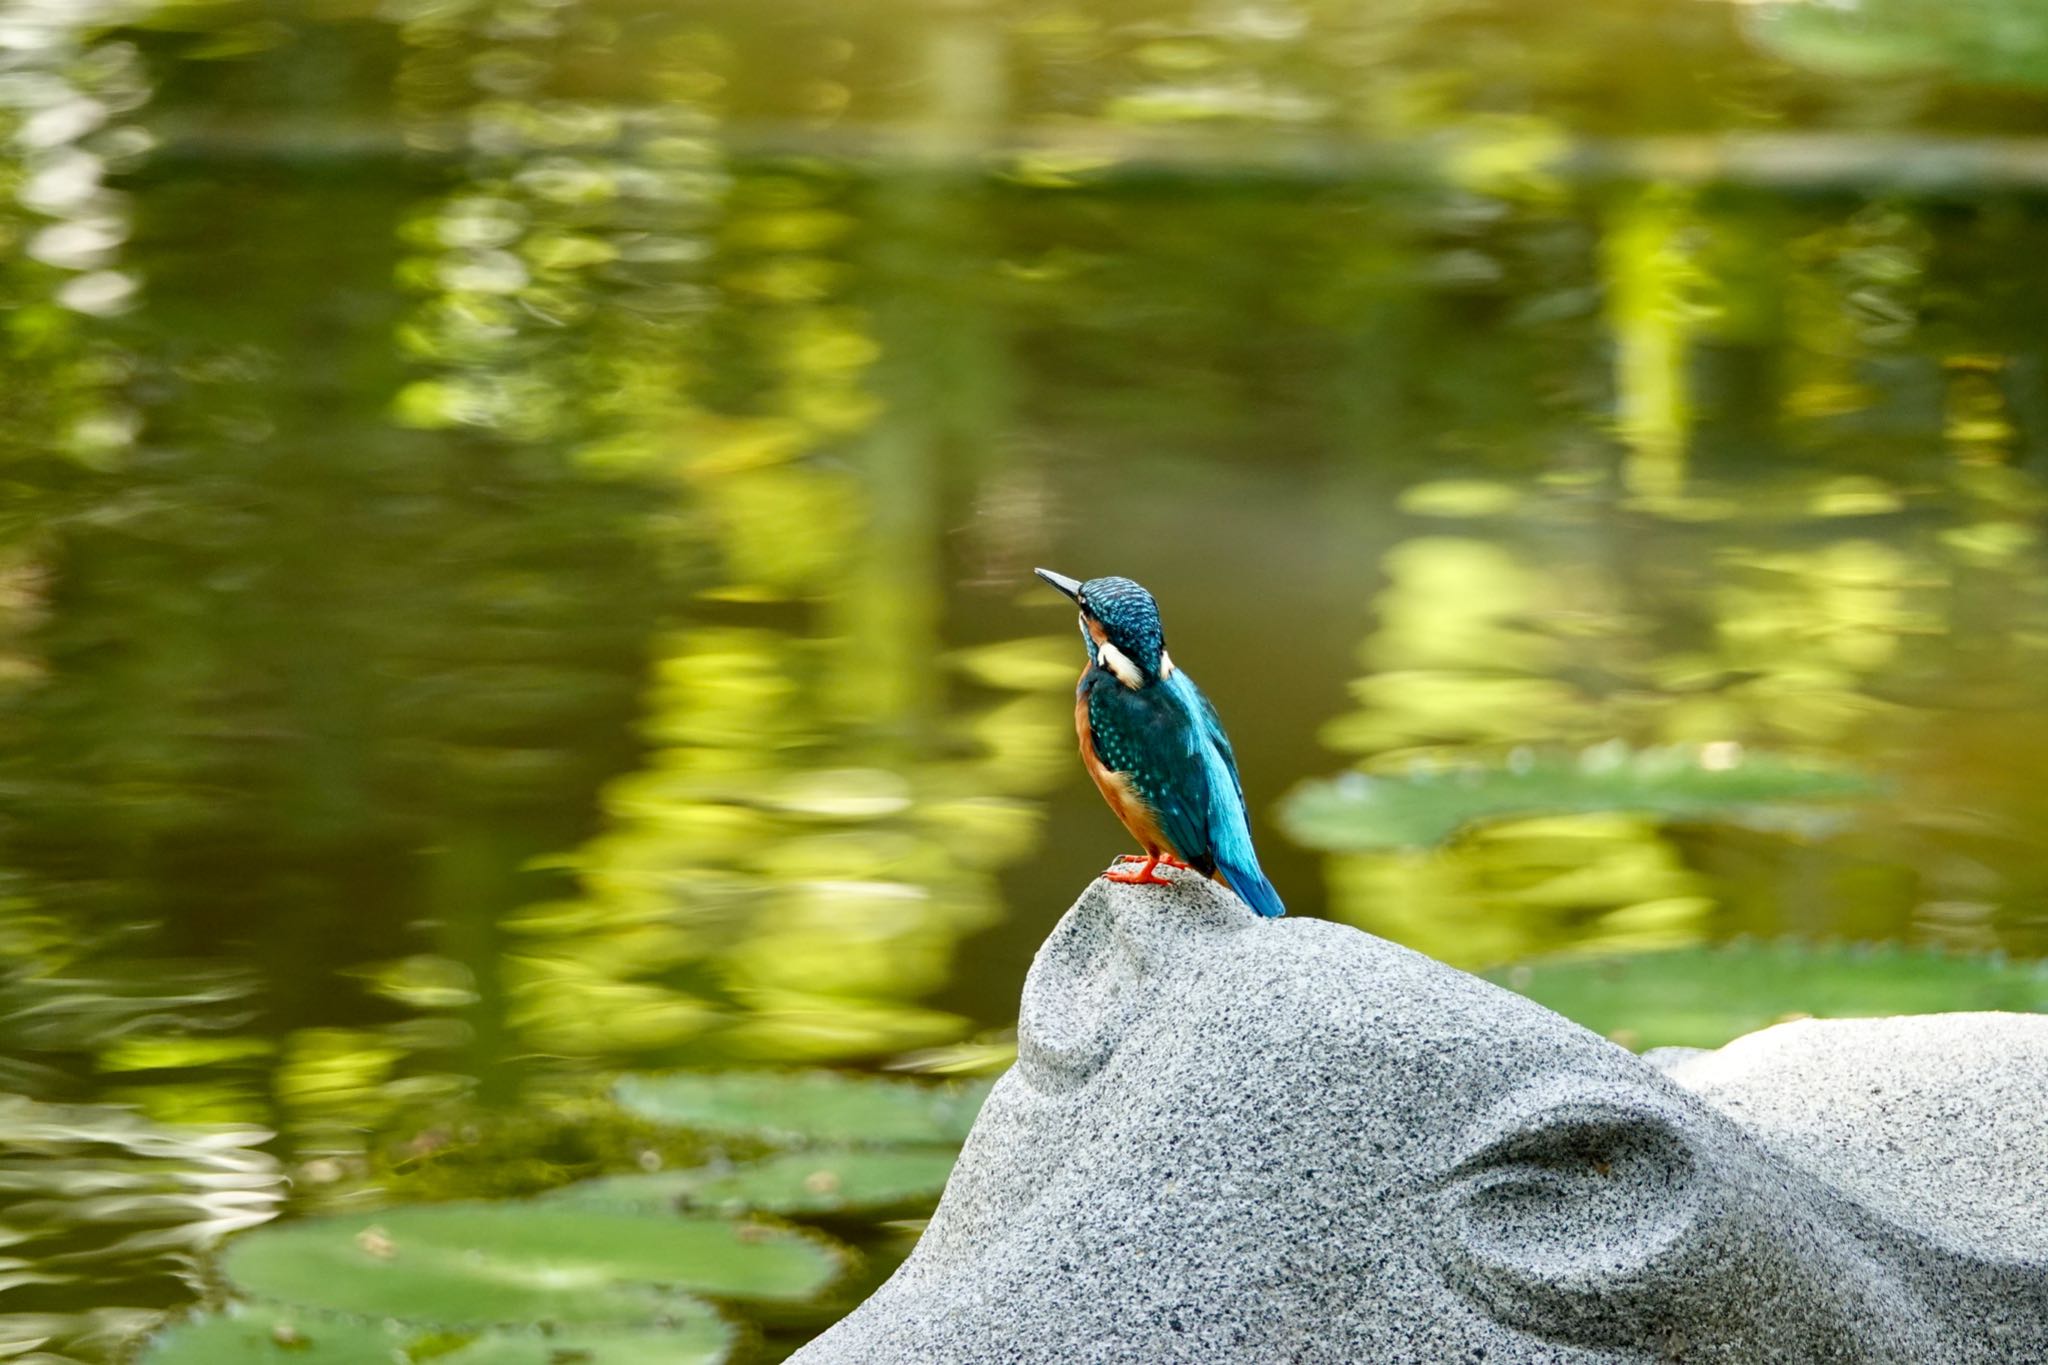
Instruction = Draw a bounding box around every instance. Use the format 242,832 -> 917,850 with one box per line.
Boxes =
139,1304 -> 733,1365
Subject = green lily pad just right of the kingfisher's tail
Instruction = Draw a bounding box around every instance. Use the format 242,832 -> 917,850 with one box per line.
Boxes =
1280,745 -> 1878,851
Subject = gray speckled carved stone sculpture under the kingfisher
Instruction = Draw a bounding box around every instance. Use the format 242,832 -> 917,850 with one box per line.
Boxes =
795,874 -> 2048,1365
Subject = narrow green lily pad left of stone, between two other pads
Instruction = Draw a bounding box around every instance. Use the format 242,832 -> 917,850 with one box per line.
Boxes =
549,1148 -> 958,1216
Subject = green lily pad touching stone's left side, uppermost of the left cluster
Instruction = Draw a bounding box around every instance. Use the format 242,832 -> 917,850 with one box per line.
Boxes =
614,1070 -> 993,1144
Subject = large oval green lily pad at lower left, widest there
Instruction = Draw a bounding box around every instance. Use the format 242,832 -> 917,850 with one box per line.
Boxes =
221,1203 -> 840,1326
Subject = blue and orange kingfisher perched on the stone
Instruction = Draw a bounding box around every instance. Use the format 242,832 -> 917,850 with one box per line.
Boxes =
1034,569 -> 1286,919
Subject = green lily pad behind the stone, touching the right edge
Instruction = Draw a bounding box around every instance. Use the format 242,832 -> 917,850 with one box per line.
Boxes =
1487,941 -> 2048,1048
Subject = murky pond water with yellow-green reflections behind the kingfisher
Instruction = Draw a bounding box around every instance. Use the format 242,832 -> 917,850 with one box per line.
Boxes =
0,0 -> 2048,1357
